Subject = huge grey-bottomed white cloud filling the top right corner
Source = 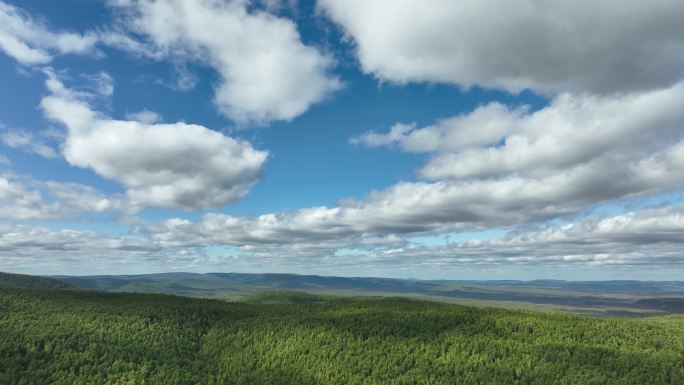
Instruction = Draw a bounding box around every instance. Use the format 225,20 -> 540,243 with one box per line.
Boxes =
317,0 -> 684,93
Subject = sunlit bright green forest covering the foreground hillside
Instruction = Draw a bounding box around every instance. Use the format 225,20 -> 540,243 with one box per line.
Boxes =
0,289 -> 684,385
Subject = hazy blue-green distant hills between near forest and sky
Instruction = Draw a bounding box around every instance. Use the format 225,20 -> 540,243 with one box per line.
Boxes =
53,272 -> 684,315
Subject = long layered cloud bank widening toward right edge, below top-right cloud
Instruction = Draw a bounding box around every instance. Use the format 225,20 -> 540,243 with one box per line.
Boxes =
142,93 -> 684,252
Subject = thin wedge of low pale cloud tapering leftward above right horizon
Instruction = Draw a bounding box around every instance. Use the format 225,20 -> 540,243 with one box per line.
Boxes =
384,206 -> 684,268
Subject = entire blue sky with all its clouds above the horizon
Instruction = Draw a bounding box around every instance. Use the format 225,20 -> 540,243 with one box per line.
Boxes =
0,0 -> 684,279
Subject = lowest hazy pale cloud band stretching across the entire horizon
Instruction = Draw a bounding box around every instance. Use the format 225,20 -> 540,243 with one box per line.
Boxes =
0,206 -> 684,278
